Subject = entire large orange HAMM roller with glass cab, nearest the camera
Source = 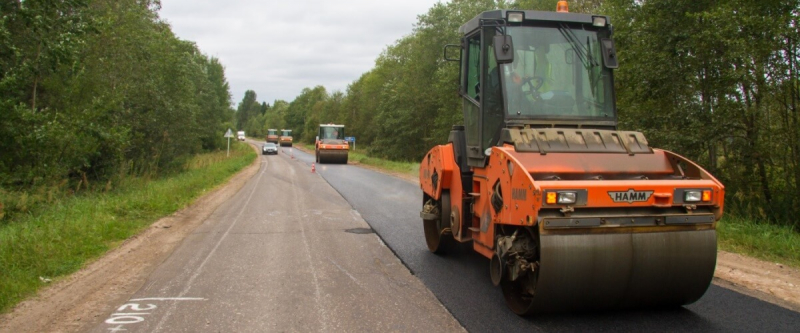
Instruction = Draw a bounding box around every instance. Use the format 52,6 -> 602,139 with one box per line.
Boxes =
420,10 -> 724,315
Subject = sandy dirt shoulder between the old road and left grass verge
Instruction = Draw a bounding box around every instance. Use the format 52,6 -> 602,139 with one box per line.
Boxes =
0,147 -> 261,332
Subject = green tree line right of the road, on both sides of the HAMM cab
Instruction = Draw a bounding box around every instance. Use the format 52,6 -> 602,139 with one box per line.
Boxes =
240,0 -> 800,226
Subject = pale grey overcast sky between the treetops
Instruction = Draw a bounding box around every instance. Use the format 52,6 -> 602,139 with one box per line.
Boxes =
160,0 -> 446,106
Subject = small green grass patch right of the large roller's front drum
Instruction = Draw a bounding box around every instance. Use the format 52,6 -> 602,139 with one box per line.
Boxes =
717,215 -> 800,268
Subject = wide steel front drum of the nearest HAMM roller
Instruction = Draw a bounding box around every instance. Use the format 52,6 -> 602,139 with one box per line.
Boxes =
503,229 -> 717,315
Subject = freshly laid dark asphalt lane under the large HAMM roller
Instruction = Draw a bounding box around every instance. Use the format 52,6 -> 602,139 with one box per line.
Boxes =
288,150 -> 800,332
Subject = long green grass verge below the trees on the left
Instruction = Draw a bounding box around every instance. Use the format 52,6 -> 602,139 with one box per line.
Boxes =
0,144 -> 257,313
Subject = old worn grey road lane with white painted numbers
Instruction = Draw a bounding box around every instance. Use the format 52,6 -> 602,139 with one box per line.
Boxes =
92,145 -> 463,332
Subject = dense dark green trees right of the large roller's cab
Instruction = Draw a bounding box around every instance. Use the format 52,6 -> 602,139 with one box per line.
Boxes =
601,0 -> 800,225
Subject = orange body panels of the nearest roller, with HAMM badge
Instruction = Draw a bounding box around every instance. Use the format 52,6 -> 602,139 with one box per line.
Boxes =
420,143 -> 725,258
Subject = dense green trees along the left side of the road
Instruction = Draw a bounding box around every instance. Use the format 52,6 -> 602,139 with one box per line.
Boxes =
0,0 -> 234,190
